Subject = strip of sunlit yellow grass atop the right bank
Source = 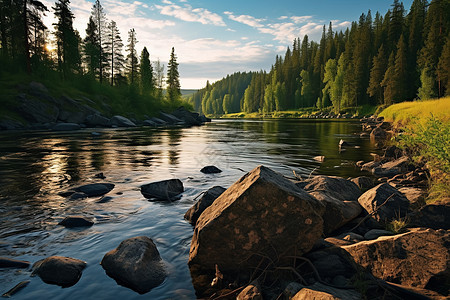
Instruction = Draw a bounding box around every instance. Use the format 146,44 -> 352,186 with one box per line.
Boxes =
379,97 -> 450,126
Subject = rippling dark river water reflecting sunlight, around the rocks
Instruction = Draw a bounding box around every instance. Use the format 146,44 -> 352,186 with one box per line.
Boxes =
0,120 -> 373,299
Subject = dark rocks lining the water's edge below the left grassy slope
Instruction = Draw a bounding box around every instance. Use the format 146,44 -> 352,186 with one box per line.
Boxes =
0,81 -> 211,131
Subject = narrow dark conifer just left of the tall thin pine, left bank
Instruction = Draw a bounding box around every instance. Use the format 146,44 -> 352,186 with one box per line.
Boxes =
83,16 -> 101,77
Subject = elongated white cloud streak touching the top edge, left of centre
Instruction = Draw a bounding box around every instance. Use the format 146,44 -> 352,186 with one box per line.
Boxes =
155,0 -> 226,26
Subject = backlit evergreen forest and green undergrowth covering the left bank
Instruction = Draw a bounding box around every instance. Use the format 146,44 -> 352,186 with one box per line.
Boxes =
0,0 -> 182,115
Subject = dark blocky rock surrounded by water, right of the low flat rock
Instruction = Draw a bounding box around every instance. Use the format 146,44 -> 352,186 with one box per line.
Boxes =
141,179 -> 184,201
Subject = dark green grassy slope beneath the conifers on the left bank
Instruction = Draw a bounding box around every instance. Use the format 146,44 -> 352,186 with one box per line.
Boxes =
0,69 -> 190,120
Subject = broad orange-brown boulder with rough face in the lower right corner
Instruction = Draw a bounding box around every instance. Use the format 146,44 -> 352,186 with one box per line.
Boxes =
342,228 -> 450,295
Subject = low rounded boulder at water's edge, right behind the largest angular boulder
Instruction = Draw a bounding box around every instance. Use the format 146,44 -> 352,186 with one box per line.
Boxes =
303,175 -> 361,201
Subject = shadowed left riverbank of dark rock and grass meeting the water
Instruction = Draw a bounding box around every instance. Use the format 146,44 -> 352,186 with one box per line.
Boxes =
0,81 -> 211,131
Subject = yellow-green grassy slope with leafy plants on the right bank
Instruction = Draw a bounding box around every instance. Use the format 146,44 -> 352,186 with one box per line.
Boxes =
380,97 -> 450,203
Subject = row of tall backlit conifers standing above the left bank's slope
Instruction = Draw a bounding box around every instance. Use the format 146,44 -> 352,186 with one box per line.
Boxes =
0,0 -> 181,103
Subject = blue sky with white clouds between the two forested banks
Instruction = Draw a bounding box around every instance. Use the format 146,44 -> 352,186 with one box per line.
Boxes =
42,0 -> 413,89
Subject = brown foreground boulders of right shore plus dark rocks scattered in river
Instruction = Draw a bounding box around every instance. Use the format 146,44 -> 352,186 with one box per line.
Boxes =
0,117 -> 450,299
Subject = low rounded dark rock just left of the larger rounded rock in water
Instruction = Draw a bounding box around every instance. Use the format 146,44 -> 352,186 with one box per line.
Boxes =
33,256 -> 86,287
